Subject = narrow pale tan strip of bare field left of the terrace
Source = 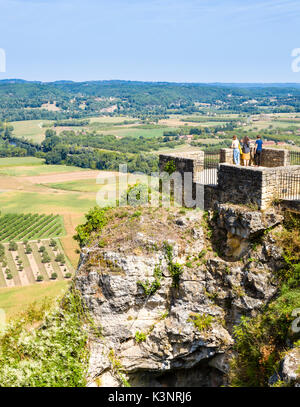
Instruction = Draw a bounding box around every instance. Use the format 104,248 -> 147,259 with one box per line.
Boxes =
24,170 -> 119,184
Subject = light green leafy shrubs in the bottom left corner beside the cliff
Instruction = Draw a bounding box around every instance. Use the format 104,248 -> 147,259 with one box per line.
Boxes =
0,293 -> 88,387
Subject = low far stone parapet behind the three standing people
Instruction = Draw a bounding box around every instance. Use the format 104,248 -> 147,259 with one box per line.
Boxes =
220,147 -> 290,168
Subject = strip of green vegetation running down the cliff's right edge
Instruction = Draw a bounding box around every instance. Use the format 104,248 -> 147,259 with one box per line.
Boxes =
230,213 -> 300,387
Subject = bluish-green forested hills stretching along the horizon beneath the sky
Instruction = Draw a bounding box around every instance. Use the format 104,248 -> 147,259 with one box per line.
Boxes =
0,80 -> 300,121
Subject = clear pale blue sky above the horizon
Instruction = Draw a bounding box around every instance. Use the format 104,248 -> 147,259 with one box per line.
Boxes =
0,0 -> 300,82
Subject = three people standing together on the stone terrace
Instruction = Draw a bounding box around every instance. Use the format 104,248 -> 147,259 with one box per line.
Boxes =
231,135 -> 263,167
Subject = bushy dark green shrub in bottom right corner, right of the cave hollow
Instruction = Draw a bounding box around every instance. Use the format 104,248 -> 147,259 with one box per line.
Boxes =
230,286 -> 300,387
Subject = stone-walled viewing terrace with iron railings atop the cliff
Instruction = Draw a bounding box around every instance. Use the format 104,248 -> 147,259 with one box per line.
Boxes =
159,148 -> 300,210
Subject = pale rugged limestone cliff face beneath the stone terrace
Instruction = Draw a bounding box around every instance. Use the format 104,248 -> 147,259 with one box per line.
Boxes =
75,205 -> 288,386
